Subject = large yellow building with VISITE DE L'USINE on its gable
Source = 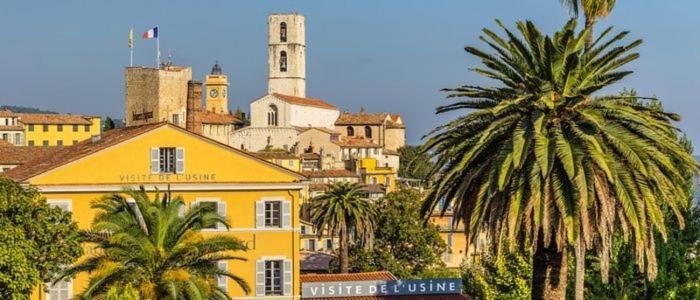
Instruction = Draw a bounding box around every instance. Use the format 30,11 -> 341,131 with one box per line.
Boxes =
6,123 -> 306,300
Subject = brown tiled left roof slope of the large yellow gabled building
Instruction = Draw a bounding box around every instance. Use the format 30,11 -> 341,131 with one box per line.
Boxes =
5,122 -> 166,181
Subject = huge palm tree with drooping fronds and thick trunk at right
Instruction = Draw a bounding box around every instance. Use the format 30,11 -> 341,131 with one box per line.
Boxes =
423,20 -> 697,299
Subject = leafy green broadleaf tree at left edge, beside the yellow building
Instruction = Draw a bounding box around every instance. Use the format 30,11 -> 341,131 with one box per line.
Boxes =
0,177 -> 83,299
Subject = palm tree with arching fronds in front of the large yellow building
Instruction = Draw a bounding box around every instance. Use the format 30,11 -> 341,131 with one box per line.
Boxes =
58,187 -> 249,300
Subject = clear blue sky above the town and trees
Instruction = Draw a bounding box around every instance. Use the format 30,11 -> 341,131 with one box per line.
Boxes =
0,0 -> 700,153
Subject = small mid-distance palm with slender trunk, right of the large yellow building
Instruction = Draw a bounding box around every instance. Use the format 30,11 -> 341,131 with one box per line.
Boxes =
310,182 -> 375,273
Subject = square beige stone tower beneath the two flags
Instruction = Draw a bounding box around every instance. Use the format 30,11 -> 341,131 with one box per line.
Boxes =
125,66 -> 192,127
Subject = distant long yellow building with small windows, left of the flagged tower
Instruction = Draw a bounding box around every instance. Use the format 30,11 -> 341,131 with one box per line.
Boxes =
18,113 -> 102,146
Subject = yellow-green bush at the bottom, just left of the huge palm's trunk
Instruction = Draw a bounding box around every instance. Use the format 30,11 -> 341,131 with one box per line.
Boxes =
462,251 -> 532,300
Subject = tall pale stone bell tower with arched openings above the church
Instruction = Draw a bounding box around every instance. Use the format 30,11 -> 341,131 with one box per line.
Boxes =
267,14 -> 306,98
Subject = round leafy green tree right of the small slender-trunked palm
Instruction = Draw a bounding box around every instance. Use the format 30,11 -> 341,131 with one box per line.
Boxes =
349,189 -> 447,279
